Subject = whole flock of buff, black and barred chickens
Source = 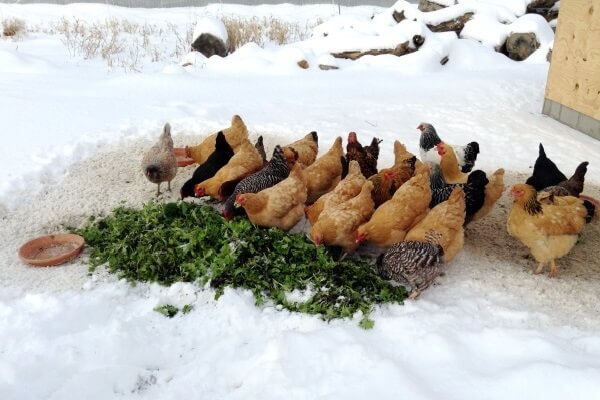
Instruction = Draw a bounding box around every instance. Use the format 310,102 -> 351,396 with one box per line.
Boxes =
142,115 -> 594,298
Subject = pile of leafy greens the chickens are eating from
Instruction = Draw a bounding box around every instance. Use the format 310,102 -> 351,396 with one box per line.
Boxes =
77,202 -> 406,328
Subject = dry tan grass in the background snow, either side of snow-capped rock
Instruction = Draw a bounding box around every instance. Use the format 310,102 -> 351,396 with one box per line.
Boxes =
2,17 -> 320,71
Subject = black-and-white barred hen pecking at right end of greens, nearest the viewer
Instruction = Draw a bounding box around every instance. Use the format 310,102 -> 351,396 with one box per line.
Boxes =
377,241 -> 444,298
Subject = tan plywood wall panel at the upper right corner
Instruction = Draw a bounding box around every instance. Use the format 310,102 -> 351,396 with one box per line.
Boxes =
546,0 -> 600,119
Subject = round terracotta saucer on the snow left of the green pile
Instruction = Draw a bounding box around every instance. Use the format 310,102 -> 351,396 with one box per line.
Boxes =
19,233 -> 85,267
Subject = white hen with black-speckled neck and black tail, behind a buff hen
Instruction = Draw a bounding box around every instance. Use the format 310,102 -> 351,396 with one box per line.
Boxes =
417,122 -> 479,173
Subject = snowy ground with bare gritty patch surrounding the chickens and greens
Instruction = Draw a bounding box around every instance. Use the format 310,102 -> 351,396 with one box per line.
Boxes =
0,2 -> 600,400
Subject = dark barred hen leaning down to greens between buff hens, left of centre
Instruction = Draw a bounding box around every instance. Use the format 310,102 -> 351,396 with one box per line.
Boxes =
223,145 -> 297,220
